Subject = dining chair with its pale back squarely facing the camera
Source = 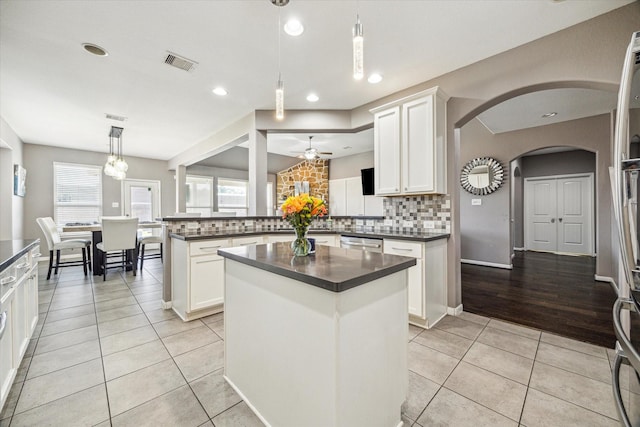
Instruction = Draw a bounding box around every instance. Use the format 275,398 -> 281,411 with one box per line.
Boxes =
96,217 -> 138,281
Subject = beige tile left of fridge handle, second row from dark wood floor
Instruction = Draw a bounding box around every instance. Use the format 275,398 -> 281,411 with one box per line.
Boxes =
536,343 -> 611,384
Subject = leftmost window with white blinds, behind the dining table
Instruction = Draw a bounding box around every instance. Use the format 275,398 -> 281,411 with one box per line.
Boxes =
53,162 -> 102,225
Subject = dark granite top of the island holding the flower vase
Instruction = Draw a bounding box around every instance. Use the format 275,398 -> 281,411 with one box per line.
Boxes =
218,242 -> 416,292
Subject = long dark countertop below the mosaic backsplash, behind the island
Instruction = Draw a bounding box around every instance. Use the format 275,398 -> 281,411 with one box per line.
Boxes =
170,228 -> 449,242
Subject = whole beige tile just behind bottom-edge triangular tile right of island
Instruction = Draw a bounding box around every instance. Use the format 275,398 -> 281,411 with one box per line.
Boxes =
444,362 -> 527,421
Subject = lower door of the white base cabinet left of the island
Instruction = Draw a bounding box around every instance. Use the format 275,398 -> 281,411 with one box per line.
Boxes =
189,255 -> 224,311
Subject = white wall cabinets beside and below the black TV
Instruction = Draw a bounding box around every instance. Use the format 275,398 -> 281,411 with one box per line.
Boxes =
329,176 -> 383,216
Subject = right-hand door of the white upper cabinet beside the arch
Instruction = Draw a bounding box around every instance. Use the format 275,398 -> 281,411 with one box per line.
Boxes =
402,96 -> 436,193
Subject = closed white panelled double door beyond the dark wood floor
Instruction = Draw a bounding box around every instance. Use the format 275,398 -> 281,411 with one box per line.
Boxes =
524,174 -> 594,255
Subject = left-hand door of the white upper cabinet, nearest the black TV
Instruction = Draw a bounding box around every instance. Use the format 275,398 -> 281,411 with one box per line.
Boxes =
373,107 -> 400,195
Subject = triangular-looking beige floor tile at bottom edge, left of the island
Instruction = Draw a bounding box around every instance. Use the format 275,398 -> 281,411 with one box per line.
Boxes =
112,385 -> 209,427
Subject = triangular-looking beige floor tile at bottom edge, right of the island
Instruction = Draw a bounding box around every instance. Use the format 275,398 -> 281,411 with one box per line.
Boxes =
418,387 -> 518,427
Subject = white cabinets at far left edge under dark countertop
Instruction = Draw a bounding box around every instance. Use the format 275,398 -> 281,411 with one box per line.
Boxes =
0,246 -> 40,407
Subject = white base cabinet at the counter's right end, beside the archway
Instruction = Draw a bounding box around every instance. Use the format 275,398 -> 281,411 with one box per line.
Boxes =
384,239 -> 447,328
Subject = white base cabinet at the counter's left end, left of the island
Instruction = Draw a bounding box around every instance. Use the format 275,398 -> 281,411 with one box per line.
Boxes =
171,239 -> 231,321
